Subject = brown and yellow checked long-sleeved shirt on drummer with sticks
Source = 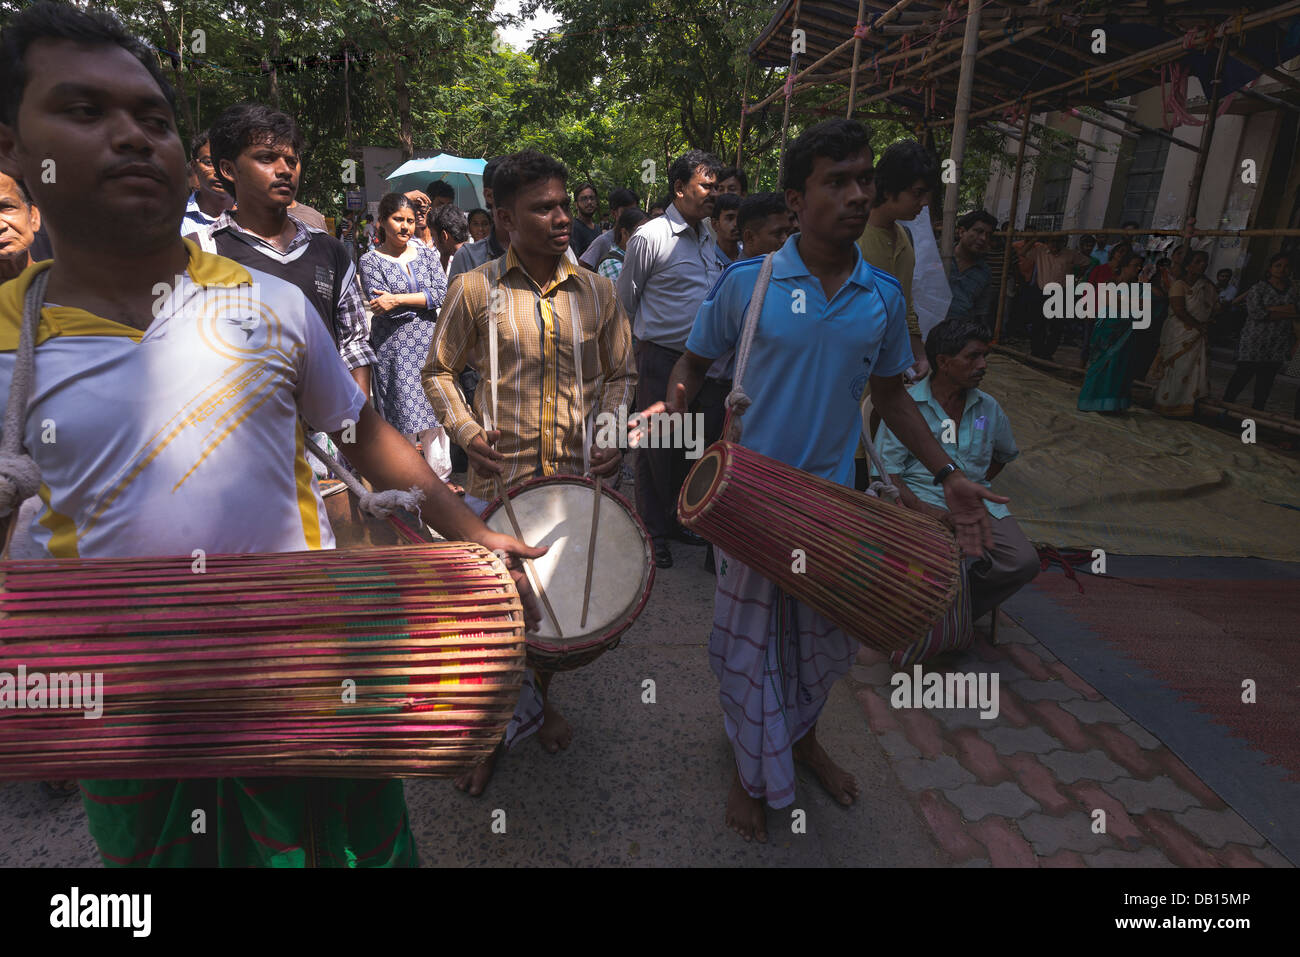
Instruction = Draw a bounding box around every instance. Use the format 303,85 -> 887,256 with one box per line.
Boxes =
421,250 -> 637,499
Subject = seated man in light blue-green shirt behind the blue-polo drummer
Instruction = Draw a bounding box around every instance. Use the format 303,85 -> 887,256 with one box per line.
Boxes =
876,316 -> 1039,620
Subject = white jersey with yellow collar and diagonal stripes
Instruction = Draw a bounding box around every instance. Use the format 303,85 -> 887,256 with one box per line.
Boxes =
0,241 -> 365,559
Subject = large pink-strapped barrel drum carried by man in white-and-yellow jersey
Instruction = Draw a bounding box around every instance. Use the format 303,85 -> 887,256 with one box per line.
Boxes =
0,542 -> 525,780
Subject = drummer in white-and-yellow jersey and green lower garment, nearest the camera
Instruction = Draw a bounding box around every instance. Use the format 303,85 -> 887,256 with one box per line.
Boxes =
0,4 -> 545,867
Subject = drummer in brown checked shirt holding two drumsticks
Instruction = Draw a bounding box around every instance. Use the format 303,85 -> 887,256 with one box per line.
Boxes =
424,150 -> 637,794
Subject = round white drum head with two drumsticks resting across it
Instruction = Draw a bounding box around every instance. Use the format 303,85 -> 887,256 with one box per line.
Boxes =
484,476 -> 654,651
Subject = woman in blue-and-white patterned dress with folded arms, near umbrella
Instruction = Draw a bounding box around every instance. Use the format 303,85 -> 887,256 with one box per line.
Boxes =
360,192 -> 459,492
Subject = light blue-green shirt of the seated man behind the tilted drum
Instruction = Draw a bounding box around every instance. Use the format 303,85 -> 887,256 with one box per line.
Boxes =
875,374 -> 1021,519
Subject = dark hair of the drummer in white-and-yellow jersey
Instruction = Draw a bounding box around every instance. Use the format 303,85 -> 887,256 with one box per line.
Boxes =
0,3 -> 176,126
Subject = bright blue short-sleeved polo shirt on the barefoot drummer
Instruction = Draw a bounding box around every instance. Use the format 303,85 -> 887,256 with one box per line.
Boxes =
686,234 -> 914,488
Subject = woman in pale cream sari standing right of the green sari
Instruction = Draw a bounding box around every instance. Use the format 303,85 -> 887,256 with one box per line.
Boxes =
1147,250 -> 1218,419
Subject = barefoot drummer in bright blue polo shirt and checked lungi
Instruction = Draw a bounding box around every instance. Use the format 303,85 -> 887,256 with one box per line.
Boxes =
646,120 -> 1006,840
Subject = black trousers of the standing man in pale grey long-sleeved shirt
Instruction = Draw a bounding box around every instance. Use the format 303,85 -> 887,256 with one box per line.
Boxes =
637,339 -> 731,542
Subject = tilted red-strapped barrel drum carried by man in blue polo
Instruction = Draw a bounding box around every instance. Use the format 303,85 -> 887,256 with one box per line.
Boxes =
677,441 -> 959,651
